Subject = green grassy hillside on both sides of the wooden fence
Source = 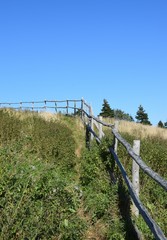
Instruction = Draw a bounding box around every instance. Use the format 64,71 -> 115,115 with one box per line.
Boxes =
0,109 -> 167,240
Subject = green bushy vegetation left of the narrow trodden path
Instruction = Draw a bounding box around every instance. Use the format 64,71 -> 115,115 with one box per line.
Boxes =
0,110 -> 86,240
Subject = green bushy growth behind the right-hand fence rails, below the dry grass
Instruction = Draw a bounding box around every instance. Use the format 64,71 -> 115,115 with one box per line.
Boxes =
118,132 -> 167,239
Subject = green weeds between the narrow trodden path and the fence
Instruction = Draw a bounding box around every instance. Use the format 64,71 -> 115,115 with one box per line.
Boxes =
80,137 -> 137,240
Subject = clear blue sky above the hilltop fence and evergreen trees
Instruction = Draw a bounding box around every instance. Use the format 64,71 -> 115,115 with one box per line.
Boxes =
0,0 -> 167,125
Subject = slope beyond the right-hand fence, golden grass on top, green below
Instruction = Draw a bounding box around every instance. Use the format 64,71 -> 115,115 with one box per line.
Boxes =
103,121 -> 167,239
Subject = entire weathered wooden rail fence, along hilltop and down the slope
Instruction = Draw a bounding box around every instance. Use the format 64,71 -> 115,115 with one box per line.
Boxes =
0,99 -> 167,240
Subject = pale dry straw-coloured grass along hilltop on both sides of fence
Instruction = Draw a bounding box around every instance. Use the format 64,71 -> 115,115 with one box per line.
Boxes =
5,108 -> 167,142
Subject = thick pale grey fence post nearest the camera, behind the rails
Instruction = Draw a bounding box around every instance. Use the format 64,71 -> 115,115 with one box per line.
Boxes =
132,140 -> 140,217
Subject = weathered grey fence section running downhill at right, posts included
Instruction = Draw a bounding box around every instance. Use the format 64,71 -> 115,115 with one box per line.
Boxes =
81,103 -> 167,240
